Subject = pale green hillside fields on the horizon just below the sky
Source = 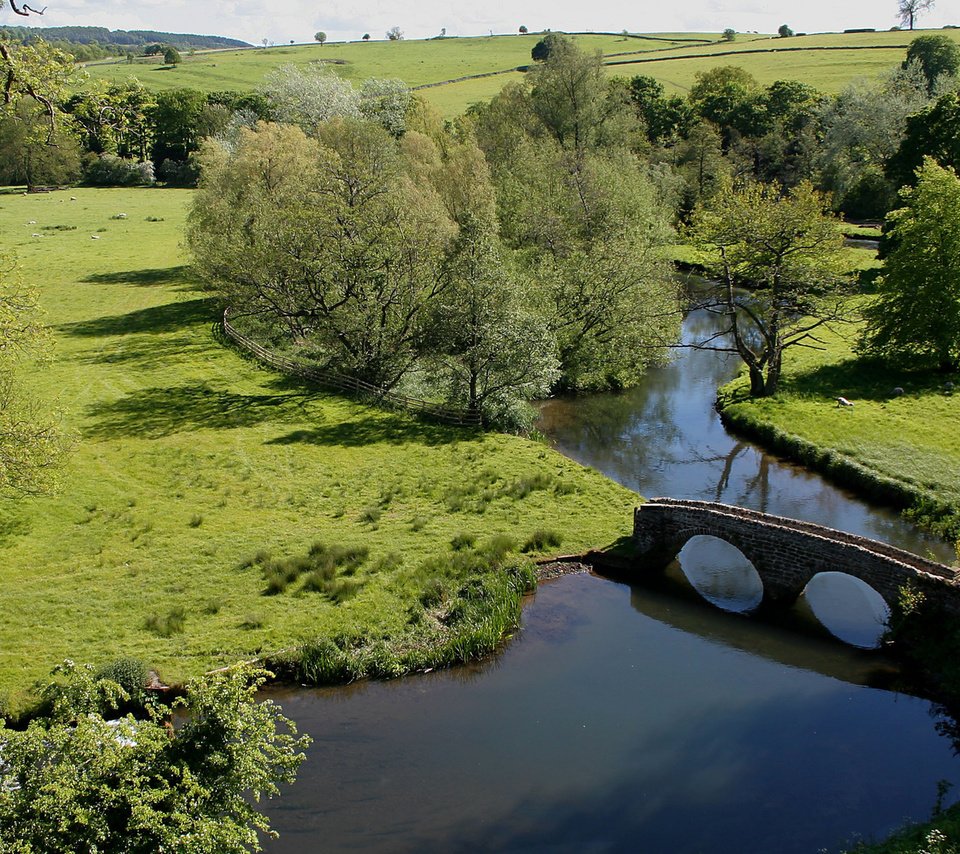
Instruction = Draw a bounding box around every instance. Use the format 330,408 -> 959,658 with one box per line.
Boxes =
75,30 -> 960,116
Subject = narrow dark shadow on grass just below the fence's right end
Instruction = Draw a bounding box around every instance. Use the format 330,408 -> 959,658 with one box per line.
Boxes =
265,413 -> 460,448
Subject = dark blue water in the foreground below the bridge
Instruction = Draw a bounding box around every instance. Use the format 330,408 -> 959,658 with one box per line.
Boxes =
266,575 -> 958,854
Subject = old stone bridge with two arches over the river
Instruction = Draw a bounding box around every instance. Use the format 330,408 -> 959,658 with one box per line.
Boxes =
633,498 -> 960,615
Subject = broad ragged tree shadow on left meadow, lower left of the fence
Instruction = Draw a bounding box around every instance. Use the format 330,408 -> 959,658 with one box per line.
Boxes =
84,384 -> 317,439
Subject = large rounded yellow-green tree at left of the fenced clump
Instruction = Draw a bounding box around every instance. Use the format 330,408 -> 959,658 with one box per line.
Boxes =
187,119 -> 454,389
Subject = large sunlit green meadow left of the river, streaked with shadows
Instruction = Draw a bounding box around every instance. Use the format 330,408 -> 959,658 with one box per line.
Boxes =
0,189 -> 637,710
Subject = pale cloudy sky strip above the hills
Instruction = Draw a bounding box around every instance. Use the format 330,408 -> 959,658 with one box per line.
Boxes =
0,0 -> 960,44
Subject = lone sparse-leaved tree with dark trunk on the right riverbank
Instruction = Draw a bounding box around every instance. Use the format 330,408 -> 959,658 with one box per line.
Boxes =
689,183 -> 843,397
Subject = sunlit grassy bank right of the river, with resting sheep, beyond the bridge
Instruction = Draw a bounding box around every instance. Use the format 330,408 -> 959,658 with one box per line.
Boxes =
720,308 -> 960,540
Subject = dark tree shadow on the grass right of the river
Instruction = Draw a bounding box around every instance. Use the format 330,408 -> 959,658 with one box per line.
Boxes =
783,359 -> 947,401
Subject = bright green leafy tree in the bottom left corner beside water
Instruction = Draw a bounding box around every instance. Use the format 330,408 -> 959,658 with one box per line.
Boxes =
0,661 -> 309,854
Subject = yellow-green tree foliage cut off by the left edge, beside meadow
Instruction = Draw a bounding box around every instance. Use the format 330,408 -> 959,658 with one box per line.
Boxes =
0,255 -> 69,494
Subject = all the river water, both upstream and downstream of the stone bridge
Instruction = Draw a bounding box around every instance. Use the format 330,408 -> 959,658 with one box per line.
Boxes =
266,298 -> 960,854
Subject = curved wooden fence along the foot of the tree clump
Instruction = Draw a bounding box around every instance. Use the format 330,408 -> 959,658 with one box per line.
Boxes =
221,308 -> 482,427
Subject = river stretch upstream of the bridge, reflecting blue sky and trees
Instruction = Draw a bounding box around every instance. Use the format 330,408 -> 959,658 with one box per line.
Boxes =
539,294 -> 953,562
